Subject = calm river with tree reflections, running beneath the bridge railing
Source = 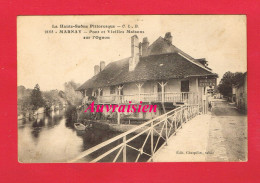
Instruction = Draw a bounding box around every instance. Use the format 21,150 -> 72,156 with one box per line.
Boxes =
18,111 -> 162,163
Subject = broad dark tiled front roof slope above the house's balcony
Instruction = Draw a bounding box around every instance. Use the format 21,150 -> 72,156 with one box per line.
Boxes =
77,52 -> 217,90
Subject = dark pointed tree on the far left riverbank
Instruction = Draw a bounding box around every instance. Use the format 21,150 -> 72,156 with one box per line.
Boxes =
31,84 -> 45,110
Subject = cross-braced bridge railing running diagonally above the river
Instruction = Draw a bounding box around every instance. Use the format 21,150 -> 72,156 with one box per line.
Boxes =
69,105 -> 200,162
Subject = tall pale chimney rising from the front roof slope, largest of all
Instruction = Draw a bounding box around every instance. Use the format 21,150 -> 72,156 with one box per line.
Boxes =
129,35 -> 140,71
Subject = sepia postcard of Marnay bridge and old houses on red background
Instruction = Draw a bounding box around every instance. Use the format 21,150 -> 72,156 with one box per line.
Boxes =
17,15 -> 248,163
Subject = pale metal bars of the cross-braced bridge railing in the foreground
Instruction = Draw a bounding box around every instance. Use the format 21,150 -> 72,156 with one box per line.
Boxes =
69,105 -> 199,162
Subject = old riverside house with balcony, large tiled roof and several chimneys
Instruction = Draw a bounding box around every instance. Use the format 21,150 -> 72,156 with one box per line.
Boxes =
77,32 -> 217,118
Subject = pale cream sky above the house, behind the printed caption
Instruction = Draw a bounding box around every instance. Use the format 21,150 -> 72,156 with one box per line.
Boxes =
17,15 -> 247,91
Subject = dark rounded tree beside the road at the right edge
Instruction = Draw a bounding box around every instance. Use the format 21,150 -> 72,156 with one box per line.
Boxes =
218,71 -> 243,97
